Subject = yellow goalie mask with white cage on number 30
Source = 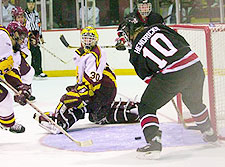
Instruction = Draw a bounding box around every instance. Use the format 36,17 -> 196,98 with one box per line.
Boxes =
81,26 -> 98,50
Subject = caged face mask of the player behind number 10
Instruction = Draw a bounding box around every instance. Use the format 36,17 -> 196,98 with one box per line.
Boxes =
137,0 -> 152,17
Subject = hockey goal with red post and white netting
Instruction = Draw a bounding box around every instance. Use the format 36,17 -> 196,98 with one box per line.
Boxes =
171,24 -> 225,140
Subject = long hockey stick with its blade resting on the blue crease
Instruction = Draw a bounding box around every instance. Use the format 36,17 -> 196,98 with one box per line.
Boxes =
0,78 -> 93,147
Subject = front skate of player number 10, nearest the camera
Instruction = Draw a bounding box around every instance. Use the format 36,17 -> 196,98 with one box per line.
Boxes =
137,131 -> 162,160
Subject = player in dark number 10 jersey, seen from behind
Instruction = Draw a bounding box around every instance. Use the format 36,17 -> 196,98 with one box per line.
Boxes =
119,23 -> 217,159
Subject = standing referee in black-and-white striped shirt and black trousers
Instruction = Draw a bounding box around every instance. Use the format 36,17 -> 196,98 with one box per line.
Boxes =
25,0 -> 47,79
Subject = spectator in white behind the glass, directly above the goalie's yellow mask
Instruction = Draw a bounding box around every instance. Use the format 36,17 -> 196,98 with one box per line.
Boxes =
80,0 -> 100,27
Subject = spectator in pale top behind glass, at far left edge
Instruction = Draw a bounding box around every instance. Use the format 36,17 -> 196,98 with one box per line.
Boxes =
2,0 -> 15,27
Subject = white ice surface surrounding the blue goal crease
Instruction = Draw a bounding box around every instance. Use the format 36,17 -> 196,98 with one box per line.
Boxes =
0,76 -> 225,167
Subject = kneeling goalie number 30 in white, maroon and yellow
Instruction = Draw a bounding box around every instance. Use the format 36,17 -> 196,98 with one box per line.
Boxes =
34,27 -> 139,131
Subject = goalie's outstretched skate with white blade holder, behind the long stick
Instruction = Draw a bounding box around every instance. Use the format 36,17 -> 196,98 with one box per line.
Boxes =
33,112 -> 60,134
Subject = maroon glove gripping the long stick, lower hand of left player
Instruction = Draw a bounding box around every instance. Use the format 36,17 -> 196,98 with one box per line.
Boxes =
14,84 -> 31,106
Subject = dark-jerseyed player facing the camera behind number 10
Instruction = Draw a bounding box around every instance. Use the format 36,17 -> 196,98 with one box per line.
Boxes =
116,0 -> 164,50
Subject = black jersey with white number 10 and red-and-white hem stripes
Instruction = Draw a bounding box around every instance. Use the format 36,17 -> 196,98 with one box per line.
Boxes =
130,24 -> 199,80
